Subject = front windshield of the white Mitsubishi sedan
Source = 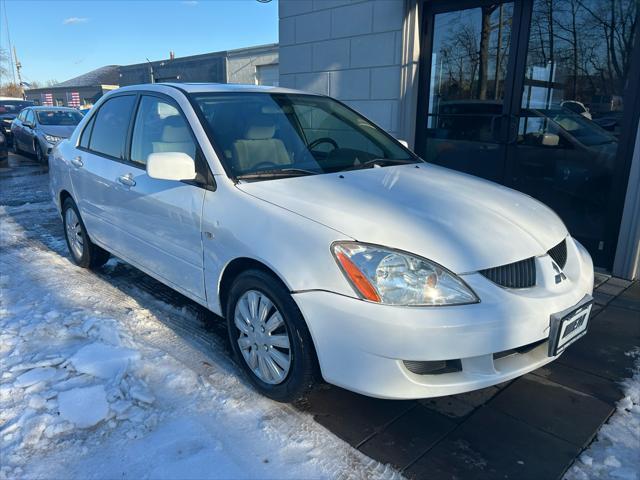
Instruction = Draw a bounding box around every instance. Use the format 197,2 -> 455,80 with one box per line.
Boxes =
193,93 -> 420,178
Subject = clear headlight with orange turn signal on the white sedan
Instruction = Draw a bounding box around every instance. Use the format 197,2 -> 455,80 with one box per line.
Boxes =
332,242 -> 479,306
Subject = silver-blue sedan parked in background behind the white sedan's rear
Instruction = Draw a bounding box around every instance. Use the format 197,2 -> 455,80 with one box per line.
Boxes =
11,107 -> 82,163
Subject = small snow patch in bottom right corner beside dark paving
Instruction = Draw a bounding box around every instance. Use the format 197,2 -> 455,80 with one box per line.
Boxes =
565,349 -> 640,480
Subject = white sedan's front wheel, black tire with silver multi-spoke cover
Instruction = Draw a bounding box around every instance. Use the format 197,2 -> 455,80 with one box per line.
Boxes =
226,270 -> 316,402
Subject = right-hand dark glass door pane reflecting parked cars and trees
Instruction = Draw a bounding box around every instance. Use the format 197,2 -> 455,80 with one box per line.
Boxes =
509,0 -> 637,264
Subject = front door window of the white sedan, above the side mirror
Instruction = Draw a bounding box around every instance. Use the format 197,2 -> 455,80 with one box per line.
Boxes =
131,96 -> 196,165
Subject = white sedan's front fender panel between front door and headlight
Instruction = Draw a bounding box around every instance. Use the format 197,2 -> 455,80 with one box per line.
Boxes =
202,186 -> 355,314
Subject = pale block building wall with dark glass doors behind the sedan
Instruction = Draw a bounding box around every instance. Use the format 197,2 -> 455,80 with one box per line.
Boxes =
279,0 -> 640,278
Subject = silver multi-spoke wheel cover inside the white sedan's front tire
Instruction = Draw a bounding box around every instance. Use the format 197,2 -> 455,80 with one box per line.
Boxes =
234,290 -> 292,385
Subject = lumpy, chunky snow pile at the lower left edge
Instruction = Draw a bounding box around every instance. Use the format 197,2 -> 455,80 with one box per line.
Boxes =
0,298 -> 156,478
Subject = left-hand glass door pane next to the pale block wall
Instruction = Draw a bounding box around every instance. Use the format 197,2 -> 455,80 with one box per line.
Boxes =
424,2 -> 513,181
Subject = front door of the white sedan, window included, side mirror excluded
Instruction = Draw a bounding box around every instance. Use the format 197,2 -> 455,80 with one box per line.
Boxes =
111,94 -> 207,301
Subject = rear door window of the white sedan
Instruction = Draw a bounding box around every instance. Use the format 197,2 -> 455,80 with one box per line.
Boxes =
85,95 -> 136,159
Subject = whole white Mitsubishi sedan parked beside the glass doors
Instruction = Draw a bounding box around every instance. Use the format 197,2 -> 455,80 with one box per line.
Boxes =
50,84 -> 593,401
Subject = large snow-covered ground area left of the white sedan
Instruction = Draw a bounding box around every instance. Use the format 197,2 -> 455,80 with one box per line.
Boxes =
0,202 -> 400,479
